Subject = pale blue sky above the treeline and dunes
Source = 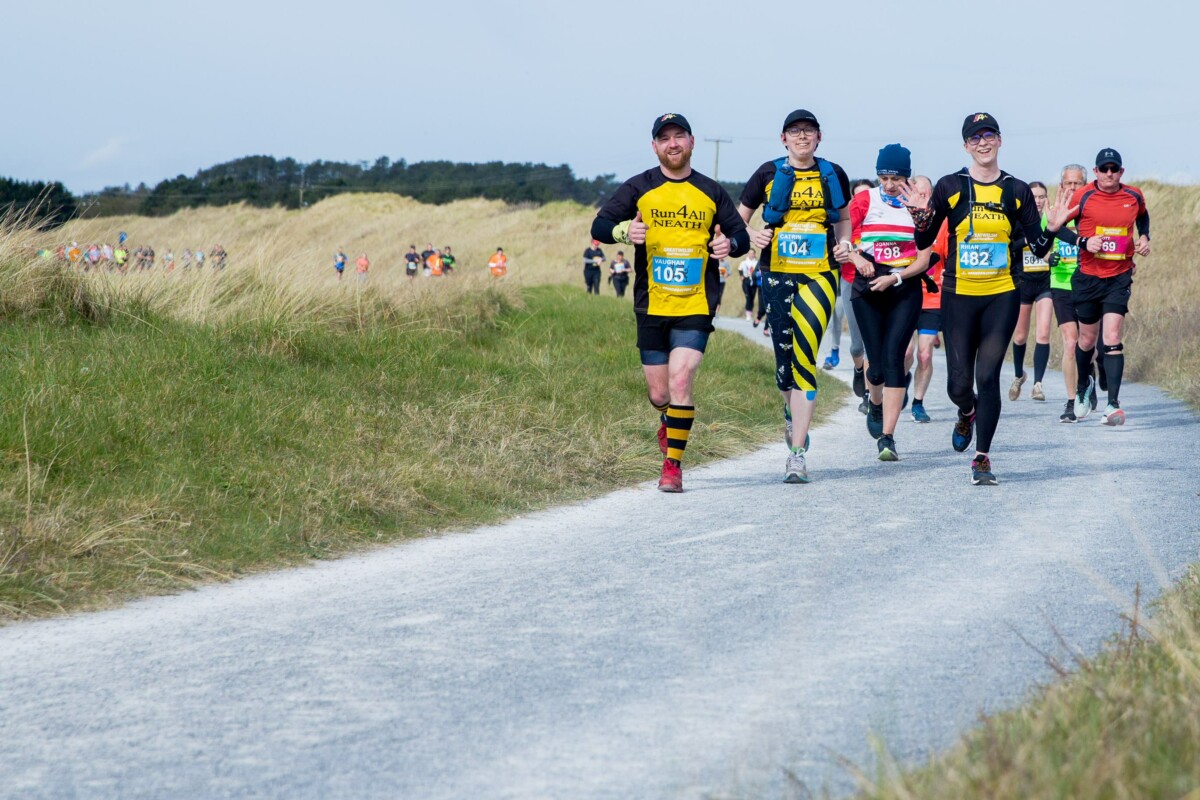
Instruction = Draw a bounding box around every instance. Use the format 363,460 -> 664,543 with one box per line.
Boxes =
0,0 -> 1200,192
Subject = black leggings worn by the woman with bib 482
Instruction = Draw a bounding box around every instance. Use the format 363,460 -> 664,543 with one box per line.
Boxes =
942,289 -> 1021,453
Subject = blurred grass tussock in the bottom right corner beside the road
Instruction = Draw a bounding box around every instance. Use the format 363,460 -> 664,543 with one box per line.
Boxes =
859,566 -> 1200,800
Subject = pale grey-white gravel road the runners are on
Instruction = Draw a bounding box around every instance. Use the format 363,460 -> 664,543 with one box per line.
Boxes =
0,323 -> 1200,799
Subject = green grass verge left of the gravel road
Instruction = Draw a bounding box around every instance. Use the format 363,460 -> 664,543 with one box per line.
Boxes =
0,287 -> 844,619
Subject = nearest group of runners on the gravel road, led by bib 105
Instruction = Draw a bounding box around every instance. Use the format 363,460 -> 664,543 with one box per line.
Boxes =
595,109 -> 1151,492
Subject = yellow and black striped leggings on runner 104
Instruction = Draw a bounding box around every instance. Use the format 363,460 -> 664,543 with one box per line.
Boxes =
762,270 -> 839,399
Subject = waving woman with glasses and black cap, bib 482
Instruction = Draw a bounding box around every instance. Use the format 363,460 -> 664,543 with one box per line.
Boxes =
906,113 -> 1067,486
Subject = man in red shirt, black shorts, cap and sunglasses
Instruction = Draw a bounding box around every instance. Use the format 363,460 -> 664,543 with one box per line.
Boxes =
1057,148 -> 1150,426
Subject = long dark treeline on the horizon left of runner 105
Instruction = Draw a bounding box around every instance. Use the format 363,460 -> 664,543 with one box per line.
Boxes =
84,156 -> 619,216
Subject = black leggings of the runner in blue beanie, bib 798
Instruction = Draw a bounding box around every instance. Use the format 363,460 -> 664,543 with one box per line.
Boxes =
850,281 -> 922,389
